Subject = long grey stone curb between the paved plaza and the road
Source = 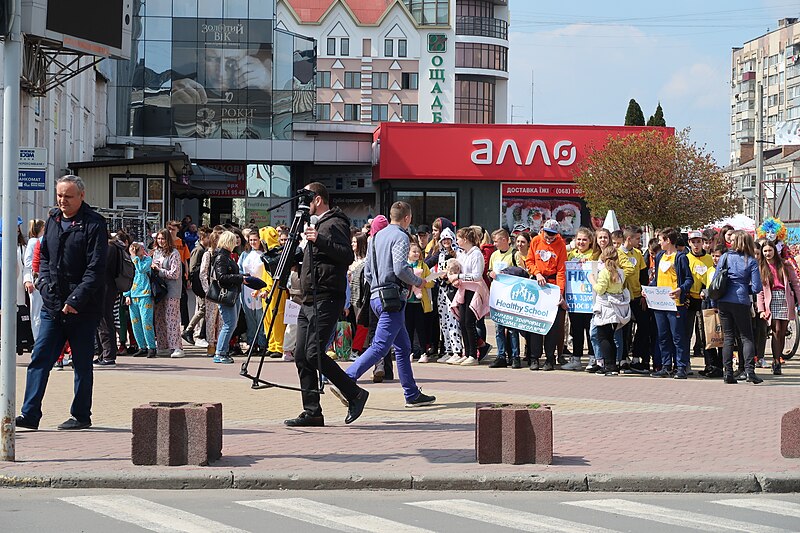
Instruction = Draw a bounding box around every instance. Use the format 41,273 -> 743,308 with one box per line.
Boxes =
0,467 -> 800,493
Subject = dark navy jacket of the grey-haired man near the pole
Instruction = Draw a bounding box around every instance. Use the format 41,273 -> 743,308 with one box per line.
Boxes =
36,202 -> 108,317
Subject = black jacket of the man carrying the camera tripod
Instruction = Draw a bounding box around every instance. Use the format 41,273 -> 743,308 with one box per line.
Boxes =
300,207 -> 355,304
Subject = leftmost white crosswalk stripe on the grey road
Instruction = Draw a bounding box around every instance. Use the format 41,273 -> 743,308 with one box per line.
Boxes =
60,495 -> 246,533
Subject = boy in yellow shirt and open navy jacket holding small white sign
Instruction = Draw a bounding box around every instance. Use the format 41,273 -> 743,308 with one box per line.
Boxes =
650,228 -> 694,379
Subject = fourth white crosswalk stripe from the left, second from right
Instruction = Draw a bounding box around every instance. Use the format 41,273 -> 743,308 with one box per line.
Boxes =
564,499 -> 786,533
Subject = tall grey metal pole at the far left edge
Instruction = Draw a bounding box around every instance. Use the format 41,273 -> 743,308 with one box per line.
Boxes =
0,0 -> 22,461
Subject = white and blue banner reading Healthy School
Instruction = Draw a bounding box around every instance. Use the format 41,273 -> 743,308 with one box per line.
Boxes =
489,274 -> 561,335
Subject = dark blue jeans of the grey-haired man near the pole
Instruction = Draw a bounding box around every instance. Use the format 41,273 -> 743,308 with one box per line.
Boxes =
22,309 -> 100,424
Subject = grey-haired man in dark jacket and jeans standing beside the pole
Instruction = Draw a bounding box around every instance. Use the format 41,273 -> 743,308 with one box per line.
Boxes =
16,175 -> 108,430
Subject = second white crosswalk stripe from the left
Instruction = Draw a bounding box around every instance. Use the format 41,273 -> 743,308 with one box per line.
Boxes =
236,498 -> 433,533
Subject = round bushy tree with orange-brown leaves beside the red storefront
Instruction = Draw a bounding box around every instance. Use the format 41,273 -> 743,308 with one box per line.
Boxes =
574,129 -> 736,228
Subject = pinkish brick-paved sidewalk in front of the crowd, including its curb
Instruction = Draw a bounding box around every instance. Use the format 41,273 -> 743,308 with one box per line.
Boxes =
0,342 -> 800,491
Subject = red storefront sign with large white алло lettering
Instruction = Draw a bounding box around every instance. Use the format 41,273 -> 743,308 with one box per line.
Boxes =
375,123 -> 675,181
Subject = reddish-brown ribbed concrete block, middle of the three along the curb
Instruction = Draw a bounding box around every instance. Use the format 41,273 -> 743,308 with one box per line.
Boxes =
475,403 -> 553,465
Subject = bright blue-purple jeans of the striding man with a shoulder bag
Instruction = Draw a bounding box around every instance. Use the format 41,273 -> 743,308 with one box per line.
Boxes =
345,298 -> 420,400
